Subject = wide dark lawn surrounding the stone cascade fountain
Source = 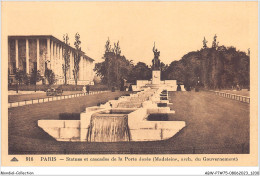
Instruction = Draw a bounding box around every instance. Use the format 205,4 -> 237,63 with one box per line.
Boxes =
8,92 -> 249,154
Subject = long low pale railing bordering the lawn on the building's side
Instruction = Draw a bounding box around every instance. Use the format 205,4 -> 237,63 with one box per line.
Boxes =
8,91 -> 108,108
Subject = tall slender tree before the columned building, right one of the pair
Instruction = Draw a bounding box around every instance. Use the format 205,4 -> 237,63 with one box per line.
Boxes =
73,33 -> 81,85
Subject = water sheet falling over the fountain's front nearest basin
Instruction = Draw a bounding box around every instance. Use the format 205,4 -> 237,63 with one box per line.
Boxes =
87,114 -> 130,142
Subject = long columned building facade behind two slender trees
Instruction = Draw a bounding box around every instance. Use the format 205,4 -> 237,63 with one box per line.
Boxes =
8,35 -> 94,85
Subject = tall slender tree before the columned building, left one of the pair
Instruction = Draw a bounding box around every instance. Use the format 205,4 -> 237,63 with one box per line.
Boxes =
62,34 -> 70,85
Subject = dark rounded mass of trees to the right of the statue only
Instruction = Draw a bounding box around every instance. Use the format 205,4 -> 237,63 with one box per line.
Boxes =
165,35 -> 250,89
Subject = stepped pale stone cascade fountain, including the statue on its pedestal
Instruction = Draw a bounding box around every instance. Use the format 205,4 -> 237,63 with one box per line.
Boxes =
38,46 -> 186,142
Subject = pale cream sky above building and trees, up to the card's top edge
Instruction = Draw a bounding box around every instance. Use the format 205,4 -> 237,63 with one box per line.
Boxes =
2,2 -> 257,65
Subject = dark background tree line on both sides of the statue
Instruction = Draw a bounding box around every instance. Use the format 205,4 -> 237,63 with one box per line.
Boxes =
94,35 -> 250,89
